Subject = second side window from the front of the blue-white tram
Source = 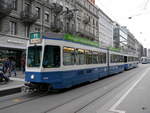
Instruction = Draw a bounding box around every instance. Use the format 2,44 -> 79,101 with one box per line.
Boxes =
76,49 -> 85,65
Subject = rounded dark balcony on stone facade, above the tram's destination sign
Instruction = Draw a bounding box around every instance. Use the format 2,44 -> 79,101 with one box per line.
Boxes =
20,10 -> 39,24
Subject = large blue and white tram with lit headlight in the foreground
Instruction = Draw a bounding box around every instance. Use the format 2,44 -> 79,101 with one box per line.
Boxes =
25,32 -> 139,90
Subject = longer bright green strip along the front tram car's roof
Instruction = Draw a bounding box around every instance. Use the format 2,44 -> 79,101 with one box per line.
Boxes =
64,34 -> 99,47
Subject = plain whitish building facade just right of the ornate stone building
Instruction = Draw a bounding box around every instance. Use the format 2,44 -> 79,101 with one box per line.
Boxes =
99,9 -> 113,48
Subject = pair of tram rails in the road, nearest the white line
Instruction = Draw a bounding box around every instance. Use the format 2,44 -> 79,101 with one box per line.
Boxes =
41,66 -> 142,113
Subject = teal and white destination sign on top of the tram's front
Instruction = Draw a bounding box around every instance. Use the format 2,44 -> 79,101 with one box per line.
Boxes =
30,32 -> 42,44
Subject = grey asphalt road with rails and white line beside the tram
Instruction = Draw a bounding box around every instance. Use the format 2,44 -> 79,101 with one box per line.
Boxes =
0,64 -> 150,113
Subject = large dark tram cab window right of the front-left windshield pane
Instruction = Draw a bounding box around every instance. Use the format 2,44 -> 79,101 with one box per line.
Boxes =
43,45 -> 60,68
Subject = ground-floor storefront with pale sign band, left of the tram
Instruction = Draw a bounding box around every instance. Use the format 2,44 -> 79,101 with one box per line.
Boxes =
0,34 -> 27,70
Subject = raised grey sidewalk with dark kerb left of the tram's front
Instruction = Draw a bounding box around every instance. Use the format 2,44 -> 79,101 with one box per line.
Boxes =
0,71 -> 24,97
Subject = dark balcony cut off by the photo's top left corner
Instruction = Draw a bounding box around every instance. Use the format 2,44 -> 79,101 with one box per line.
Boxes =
0,0 -> 13,18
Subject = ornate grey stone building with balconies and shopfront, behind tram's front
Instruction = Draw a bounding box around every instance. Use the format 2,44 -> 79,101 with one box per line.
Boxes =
0,0 -> 99,68
